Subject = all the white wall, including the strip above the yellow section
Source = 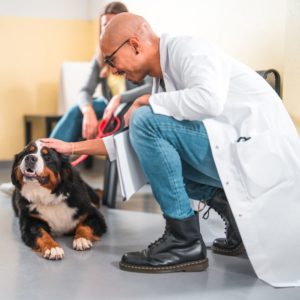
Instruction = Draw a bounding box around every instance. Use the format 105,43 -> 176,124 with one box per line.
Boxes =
0,0 -> 300,116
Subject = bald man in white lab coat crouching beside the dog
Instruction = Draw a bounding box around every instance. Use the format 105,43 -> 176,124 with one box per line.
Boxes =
100,13 -> 300,285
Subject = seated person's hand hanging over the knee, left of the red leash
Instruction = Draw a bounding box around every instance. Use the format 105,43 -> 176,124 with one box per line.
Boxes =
81,105 -> 98,140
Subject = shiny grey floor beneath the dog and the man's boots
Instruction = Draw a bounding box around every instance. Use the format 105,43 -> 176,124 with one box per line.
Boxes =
0,161 -> 300,300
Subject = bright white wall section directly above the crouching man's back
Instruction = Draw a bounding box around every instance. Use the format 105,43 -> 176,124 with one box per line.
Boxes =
112,0 -> 286,71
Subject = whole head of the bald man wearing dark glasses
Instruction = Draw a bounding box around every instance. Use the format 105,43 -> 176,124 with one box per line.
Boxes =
100,13 -> 161,82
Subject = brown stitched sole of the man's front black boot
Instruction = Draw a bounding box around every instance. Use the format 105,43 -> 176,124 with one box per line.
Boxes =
119,258 -> 208,273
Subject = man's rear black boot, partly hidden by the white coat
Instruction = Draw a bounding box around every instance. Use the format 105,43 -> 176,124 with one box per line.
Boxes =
204,189 -> 245,256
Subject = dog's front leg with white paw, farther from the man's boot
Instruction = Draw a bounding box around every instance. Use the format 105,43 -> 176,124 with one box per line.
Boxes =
20,216 -> 64,260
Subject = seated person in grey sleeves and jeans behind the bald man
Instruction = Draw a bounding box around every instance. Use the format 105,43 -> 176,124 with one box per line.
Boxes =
50,2 -> 152,142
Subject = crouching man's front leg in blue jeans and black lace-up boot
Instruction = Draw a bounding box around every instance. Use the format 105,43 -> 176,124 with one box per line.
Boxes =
120,107 -> 221,272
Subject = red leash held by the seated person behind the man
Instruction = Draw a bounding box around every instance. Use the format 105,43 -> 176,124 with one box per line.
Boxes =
71,115 -> 121,167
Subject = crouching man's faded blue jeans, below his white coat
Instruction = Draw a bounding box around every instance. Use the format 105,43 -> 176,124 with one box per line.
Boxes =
129,106 -> 222,219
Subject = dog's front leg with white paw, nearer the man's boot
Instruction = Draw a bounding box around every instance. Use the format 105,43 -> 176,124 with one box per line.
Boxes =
73,209 -> 106,251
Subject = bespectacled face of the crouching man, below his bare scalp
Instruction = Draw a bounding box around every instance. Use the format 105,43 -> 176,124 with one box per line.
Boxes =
101,38 -> 147,83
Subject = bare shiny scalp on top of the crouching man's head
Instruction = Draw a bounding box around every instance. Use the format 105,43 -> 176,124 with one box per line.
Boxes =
100,13 -> 156,53
